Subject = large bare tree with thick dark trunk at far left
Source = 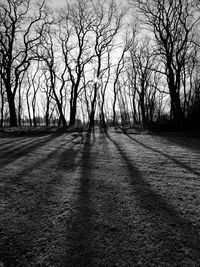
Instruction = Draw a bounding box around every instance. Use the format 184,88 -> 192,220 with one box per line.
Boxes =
0,0 -> 46,126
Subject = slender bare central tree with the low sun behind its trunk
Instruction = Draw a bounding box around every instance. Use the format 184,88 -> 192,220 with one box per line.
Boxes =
90,1 -> 125,127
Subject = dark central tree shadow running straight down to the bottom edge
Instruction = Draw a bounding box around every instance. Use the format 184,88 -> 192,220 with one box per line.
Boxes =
61,131 -> 94,267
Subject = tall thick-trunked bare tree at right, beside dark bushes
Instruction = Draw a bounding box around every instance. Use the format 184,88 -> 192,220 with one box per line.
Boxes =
133,0 -> 200,126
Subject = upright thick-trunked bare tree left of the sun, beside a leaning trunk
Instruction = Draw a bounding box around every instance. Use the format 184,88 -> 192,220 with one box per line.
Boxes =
59,0 -> 93,125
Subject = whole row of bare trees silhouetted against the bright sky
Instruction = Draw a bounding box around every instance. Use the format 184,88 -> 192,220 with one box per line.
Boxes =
0,0 -> 200,130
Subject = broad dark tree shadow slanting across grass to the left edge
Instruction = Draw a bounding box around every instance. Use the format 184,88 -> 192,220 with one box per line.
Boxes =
0,133 -> 63,168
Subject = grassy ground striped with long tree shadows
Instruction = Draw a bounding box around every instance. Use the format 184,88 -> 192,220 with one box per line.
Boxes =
0,128 -> 200,267
